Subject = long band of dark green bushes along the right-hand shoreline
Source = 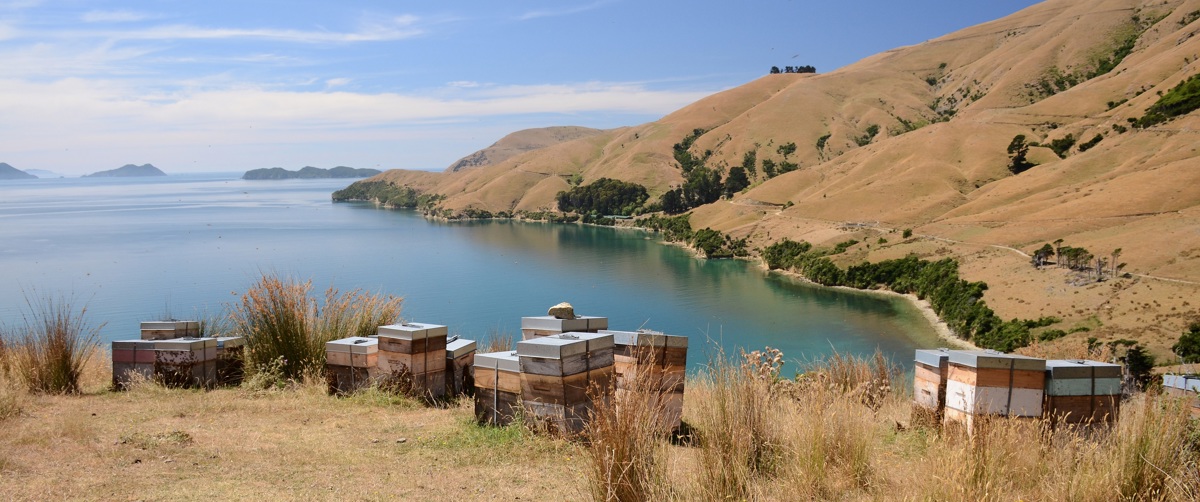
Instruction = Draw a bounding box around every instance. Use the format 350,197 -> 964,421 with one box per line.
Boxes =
762,239 -> 1057,352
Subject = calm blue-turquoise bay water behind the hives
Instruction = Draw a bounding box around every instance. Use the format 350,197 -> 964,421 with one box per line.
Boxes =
0,174 -> 937,366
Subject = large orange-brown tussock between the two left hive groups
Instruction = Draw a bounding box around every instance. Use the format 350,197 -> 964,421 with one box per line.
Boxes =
230,274 -> 402,380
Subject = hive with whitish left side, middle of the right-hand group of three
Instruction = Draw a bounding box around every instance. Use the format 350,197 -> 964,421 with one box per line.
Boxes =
943,351 -> 1046,432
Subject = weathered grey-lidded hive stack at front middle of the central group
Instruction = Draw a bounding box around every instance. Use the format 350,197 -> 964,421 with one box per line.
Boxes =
517,333 -> 613,435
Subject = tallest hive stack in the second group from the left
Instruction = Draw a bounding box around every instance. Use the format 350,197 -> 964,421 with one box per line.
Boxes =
378,323 -> 448,398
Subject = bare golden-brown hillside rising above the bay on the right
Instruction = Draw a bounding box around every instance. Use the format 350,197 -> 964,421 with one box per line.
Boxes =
355,0 -> 1200,355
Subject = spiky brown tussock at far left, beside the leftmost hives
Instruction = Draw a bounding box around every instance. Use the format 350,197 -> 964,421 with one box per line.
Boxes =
4,297 -> 103,394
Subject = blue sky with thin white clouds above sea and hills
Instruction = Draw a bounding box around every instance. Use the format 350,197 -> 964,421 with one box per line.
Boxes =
0,0 -> 1034,174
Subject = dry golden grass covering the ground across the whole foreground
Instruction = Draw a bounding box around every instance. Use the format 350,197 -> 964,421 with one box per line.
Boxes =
0,343 -> 1200,501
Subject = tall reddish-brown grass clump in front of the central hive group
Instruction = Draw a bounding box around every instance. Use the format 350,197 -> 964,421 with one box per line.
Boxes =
583,361 -> 671,501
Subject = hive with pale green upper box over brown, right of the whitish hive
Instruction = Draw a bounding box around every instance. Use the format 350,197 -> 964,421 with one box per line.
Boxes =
1044,360 -> 1121,425
